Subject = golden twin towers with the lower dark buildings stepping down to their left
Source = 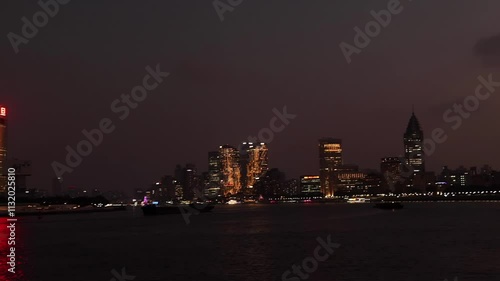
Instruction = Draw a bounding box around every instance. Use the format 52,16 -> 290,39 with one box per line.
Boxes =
143,142 -> 268,200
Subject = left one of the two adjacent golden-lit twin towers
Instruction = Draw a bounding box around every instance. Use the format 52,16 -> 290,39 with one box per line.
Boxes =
219,145 -> 241,195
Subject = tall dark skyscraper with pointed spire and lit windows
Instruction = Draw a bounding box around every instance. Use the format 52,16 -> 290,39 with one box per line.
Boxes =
404,111 -> 425,175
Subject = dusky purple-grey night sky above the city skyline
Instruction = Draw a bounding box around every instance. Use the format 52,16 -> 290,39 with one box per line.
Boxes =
0,0 -> 500,191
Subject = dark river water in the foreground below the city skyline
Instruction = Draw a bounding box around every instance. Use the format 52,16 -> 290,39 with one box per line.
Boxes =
0,203 -> 500,281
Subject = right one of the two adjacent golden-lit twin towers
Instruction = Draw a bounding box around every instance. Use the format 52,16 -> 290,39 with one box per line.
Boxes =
241,142 -> 268,191
